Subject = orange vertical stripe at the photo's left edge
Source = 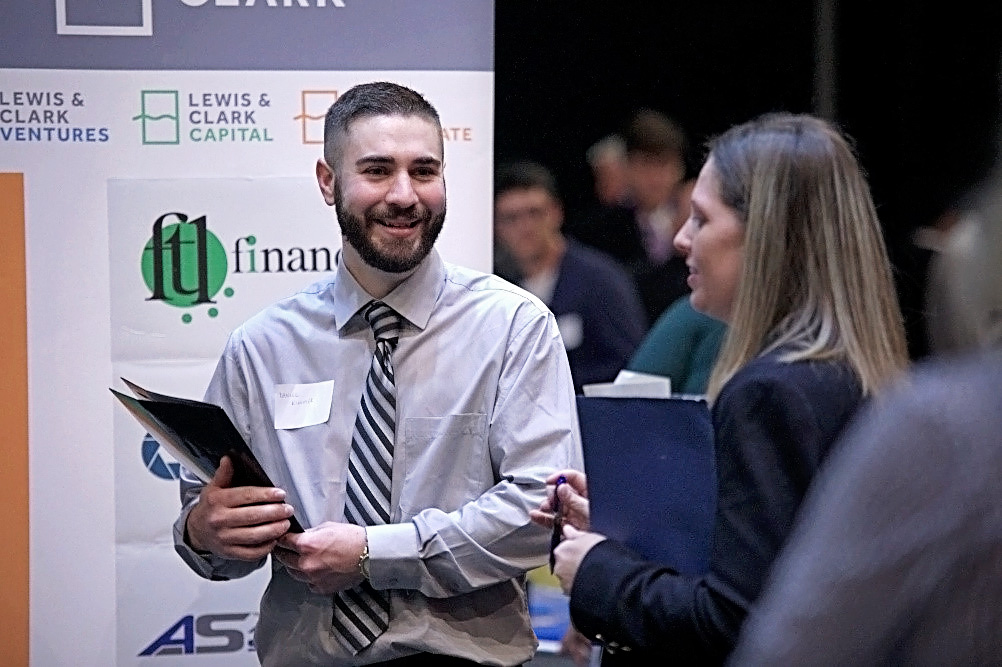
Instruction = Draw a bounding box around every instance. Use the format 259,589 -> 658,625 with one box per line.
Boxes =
0,173 -> 28,667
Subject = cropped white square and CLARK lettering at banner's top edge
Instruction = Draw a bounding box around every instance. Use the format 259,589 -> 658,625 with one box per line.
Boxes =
55,0 -> 345,37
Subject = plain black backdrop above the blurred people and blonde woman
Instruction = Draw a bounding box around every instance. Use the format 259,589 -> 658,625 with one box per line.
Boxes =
495,0 -> 1002,357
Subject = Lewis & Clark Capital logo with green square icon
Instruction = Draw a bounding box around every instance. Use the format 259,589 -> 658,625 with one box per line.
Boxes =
132,90 -> 273,146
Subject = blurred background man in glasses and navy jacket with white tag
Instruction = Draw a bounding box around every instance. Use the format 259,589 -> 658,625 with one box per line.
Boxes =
494,161 -> 646,393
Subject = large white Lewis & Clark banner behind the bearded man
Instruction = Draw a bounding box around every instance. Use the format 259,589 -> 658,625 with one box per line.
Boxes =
0,0 -> 493,652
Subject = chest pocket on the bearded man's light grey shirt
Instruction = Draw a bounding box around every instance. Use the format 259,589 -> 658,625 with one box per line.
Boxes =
394,413 -> 494,521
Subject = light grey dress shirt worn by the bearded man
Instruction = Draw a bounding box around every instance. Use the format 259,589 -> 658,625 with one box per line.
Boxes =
174,246 -> 582,667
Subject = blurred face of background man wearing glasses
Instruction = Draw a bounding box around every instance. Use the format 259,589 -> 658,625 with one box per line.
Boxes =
494,187 -> 563,266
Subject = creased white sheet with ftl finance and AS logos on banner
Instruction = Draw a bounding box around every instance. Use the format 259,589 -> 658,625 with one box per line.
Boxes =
108,177 -> 341,665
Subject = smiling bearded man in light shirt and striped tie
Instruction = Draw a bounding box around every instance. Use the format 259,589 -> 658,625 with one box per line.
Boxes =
174,83 -> 581,667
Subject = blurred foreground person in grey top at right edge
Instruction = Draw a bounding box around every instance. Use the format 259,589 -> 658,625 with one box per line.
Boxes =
732,163 -> 1002,667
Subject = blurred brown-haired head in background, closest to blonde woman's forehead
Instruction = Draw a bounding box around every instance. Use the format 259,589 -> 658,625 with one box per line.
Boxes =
623,109 -> 687,210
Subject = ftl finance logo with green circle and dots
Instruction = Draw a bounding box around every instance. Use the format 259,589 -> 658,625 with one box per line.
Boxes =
140,211 -> 334,323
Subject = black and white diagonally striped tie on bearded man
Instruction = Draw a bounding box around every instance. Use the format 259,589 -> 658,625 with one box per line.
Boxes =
333,301 -> 401,655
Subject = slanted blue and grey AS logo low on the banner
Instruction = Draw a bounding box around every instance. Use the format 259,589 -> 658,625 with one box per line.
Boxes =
138,612 -> 258,658
